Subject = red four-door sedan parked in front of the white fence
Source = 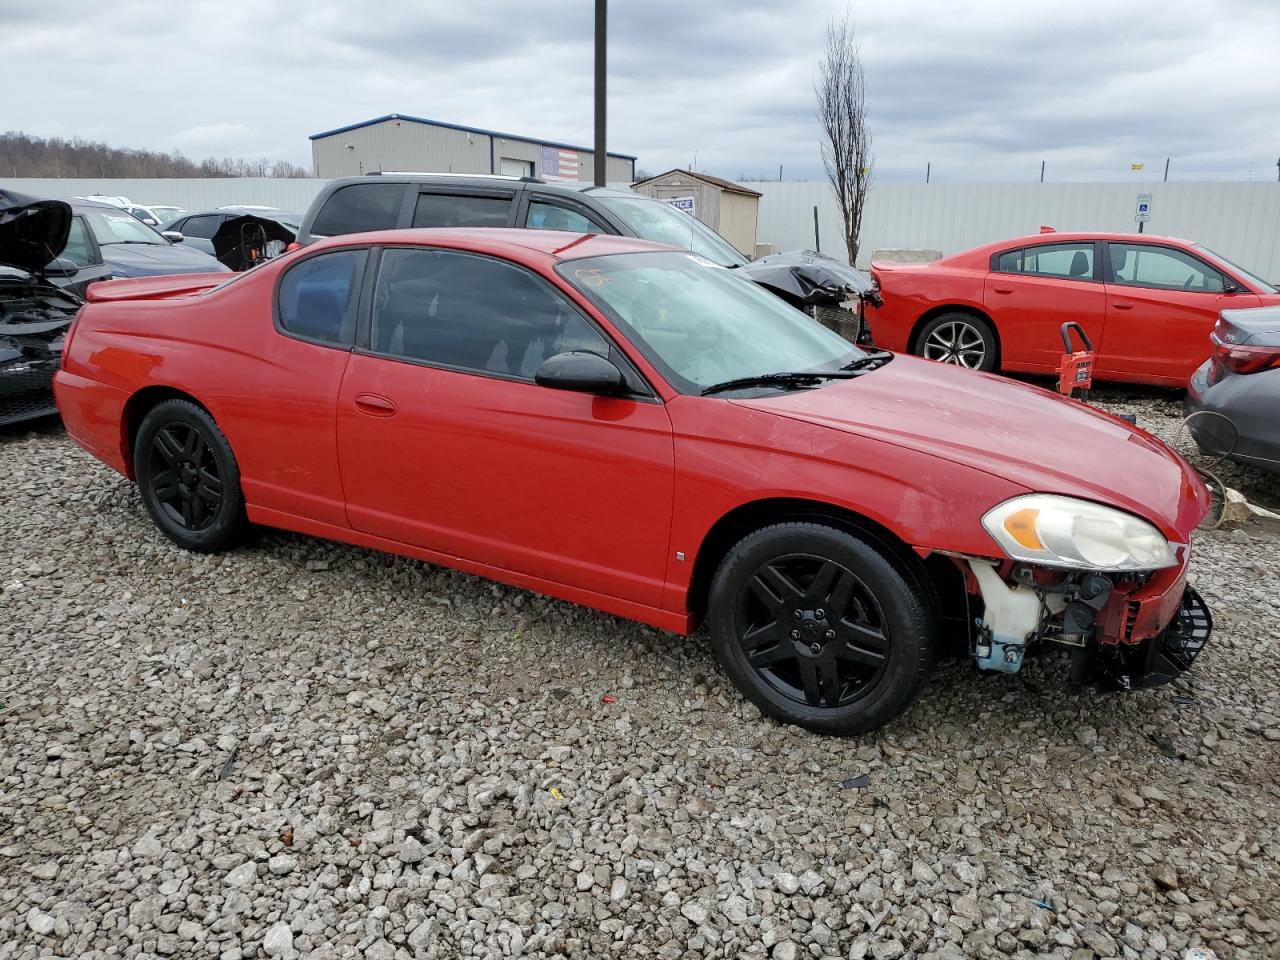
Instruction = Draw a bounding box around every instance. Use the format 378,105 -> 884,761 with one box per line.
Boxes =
867,230 -> 1280,387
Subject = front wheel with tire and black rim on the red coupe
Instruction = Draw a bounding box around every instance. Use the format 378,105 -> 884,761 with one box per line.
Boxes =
708,522 -> 936,736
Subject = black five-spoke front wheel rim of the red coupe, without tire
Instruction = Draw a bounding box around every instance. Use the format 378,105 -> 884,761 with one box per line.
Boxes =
737,554 -> 890,709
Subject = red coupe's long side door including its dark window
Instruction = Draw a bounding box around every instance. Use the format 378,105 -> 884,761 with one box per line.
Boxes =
337,247 -> 675,607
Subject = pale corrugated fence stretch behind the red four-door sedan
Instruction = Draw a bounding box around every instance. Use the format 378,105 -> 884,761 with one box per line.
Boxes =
745,180 -> 1280,280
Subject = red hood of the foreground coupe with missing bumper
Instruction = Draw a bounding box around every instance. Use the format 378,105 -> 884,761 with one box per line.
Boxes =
732,355 -> 1208,543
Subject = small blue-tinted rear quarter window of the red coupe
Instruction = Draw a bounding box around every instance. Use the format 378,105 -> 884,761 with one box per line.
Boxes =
278,250 -> 367,347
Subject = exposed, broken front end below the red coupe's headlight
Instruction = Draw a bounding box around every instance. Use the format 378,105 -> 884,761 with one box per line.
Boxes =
965,547 -> 1213,690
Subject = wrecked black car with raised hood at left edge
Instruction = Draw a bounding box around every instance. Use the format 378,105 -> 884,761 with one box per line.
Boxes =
0,189 -> 91,426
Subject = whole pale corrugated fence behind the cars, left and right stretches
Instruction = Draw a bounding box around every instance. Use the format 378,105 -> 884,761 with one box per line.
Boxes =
10,178 -> 1280,280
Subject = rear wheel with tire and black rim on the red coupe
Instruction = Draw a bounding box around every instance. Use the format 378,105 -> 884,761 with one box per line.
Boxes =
133,399 -> 247,553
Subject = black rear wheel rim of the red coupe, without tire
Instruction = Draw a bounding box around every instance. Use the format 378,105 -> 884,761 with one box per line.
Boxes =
151,422 -> 223,531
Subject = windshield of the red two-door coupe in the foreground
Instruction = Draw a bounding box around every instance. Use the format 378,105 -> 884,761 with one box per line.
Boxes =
557,253 -> 865,394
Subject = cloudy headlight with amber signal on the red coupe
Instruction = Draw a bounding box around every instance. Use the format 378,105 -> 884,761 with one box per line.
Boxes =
982,493 -> 1178,571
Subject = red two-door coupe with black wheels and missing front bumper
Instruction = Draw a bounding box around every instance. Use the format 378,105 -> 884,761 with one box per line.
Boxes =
56,230 -> 1210,733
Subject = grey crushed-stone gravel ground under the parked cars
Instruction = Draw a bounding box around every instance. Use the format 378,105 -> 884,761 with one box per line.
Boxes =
0,388 -> 1280,960
